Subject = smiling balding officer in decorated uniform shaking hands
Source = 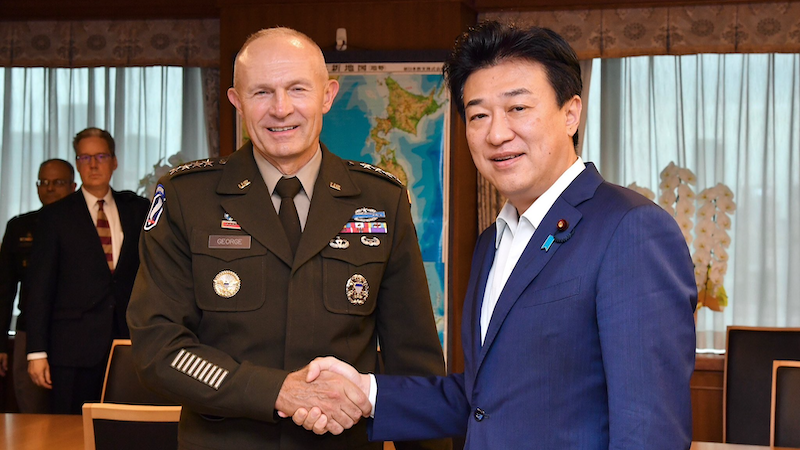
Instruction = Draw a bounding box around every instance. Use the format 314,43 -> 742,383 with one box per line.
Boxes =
128,28 -> 449,450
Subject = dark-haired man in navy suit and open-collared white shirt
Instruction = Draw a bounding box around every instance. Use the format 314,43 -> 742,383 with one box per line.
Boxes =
294,22 -> 697,450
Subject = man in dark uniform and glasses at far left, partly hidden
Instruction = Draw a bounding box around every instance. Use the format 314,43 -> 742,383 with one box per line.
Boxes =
0,159 -> 75,414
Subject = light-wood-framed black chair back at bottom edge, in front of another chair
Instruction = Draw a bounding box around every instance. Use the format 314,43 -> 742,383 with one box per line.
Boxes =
83,403 -> 181,450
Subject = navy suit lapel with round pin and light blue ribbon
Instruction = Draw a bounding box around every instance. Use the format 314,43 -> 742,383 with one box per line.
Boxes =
476,163 -> 603,372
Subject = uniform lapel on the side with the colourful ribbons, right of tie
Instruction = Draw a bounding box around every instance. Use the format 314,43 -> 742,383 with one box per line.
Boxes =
294,146 -> 364,270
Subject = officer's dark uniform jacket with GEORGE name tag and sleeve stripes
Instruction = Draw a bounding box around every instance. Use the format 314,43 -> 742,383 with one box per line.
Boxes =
128,145 -> 444,450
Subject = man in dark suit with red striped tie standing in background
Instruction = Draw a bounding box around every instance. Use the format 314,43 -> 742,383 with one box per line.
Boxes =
26,128 -> 148,414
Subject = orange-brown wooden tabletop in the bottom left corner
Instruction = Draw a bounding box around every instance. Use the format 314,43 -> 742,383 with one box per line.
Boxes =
0,414 -> 83,450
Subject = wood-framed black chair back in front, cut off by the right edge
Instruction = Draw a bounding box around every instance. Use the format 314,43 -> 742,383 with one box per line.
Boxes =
769,361 -> 800,448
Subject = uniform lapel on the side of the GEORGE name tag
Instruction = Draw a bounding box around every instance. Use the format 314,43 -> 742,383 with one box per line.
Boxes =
217,144 -> 293,266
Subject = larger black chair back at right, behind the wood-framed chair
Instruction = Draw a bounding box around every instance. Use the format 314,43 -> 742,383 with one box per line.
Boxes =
722,327 -> 800,445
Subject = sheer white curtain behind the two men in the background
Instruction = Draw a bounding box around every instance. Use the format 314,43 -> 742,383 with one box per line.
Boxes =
0,66 -> 209,234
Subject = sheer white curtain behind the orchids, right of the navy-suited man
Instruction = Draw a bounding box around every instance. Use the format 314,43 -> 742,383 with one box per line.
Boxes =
583,54 -> 800,349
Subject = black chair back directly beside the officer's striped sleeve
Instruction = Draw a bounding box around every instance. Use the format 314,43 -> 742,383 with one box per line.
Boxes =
100,339 -> 177,406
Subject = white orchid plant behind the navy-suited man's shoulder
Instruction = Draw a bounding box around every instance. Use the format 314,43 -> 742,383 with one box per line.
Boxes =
628,162 -> 736,311
